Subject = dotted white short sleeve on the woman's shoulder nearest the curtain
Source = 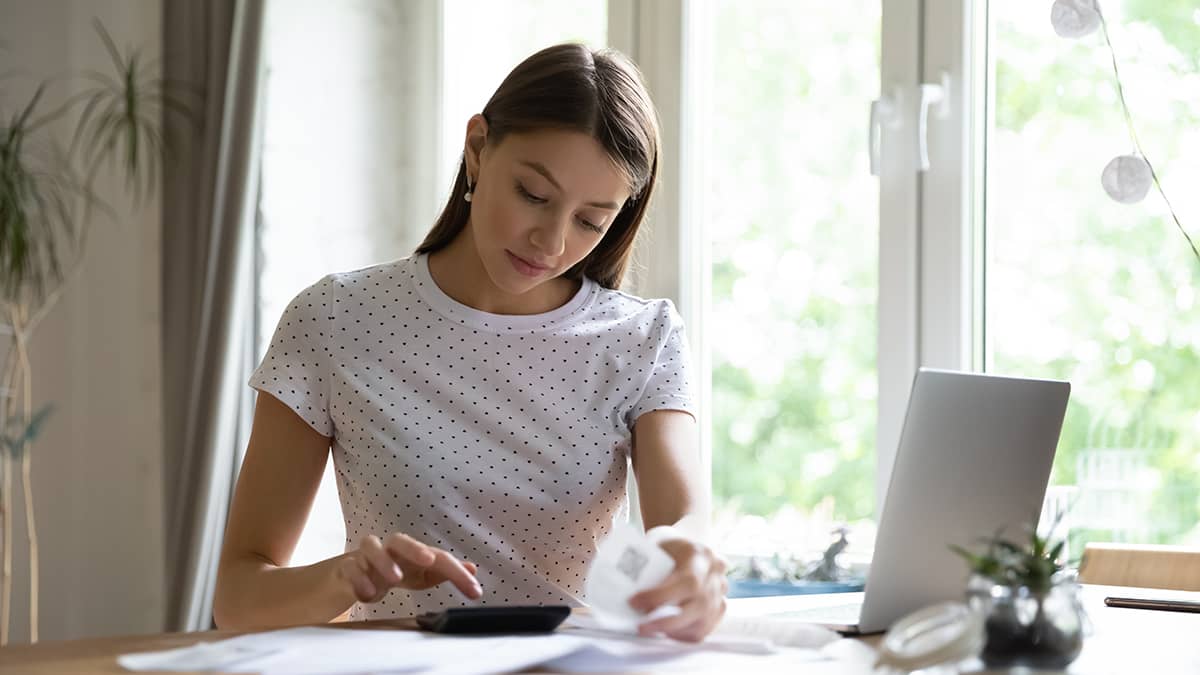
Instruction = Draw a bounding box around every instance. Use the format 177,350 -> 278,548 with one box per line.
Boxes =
250,275 -> 337,436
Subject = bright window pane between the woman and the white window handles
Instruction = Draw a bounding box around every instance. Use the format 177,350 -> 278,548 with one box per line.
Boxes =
696,0 -> 881,558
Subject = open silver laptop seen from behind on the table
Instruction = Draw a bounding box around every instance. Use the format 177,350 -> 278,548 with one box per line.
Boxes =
762,368 -> 1070,634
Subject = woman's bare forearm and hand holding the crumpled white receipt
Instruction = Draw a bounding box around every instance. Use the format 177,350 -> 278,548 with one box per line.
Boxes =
629,411 -> 728,641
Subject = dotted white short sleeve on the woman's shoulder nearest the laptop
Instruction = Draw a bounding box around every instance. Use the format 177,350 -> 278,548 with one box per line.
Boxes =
629,300 -> 696,428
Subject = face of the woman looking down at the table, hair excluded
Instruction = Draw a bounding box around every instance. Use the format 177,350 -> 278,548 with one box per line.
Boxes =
467,115 -> 629,294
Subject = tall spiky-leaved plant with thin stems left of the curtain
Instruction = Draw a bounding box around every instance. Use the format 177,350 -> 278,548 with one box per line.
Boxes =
0,19 -> 198,645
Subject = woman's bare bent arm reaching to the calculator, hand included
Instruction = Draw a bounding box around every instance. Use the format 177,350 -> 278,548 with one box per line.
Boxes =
212,393 -> 481,628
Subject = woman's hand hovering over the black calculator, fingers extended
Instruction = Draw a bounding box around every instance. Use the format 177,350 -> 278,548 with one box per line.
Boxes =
334,532 -> 484,603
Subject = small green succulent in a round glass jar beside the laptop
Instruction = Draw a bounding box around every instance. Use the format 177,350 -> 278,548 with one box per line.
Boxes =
950,527 -> 1087,668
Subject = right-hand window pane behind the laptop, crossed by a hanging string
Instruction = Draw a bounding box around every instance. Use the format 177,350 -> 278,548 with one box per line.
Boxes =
983,0 -> 1200,555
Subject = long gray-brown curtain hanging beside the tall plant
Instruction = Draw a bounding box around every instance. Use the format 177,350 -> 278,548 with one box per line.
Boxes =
162,0 -> 264,631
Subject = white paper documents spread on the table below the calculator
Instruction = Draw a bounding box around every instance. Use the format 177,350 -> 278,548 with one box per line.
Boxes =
118,617 -> 869,675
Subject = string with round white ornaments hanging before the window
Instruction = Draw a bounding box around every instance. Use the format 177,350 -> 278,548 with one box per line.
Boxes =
1050,0 -> 1200,261
